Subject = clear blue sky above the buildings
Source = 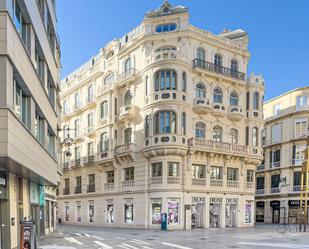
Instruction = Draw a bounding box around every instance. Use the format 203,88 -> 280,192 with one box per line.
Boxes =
57,0 -> 309,100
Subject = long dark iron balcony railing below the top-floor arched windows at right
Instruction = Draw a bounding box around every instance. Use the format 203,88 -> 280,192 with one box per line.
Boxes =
193,58 -> 246,81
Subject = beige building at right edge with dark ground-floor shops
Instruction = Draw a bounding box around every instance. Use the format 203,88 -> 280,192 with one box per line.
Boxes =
256,87 -> 309,223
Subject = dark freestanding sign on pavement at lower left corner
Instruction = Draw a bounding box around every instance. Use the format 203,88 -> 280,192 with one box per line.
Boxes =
20,221 -> 36,249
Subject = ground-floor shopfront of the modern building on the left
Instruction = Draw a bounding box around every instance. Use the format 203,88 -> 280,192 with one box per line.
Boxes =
0,169 -> 56,249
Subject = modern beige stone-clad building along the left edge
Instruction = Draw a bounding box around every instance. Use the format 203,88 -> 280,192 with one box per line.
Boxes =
0,0 -> 60,249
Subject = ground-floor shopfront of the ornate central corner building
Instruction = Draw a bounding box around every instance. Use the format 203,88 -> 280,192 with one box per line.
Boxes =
57,192 -> 254,230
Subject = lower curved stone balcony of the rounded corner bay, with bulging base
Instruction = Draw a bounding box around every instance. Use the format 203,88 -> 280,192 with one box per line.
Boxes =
143,134 -> 187,158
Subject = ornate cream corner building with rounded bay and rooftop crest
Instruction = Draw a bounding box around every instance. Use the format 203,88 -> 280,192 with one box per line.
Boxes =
57,2 -> 264,229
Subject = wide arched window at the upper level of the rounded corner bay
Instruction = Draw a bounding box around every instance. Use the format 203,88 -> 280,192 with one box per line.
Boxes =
155,69 -> 177,91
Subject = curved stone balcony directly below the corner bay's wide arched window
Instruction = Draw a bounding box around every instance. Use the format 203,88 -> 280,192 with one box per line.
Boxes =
145,90 -> 186,104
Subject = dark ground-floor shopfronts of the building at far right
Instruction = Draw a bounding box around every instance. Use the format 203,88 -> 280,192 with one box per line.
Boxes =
255,197 -> 309,224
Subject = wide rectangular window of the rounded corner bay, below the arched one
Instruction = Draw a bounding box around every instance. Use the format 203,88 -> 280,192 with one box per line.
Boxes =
155,111 -> 177,134
